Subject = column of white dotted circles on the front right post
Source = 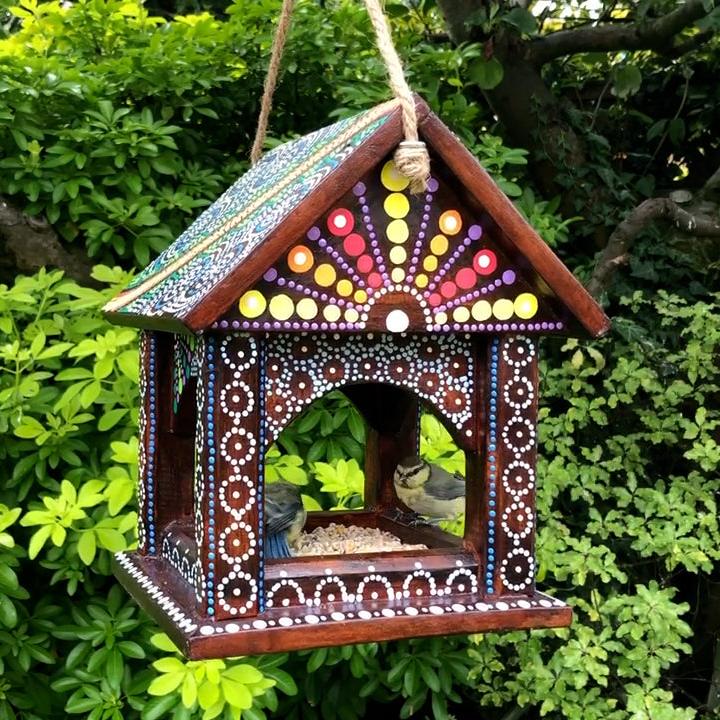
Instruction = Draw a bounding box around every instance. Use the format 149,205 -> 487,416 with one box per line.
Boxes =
494,336 -> 537,592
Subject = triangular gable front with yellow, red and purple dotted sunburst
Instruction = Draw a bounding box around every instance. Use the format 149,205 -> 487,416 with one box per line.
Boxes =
218,160 -> 563,332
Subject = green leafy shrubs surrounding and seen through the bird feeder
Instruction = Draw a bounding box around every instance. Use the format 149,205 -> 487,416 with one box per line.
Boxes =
0,0 -> 720,720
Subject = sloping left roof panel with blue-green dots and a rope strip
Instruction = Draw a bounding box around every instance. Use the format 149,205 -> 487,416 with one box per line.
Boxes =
106,102 -> 396,318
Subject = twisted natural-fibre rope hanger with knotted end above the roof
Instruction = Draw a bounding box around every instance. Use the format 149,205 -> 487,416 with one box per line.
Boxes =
250,0 -> 430,193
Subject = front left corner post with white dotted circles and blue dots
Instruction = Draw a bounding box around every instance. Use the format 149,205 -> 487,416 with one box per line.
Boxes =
194,334 -> 264,620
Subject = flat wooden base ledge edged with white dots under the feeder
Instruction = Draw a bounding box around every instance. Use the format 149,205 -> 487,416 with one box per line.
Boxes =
114,553 -> 572,659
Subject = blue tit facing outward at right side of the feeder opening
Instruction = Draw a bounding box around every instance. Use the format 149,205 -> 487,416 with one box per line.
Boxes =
393,455 -> 465,520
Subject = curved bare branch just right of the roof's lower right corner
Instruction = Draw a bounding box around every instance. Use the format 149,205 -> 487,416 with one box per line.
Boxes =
587,198 -> 720,297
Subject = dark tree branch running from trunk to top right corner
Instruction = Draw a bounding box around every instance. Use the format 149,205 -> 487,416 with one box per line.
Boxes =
529,0 -> 708,65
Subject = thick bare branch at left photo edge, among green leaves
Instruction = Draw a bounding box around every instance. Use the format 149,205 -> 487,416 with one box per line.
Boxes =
0,196 -> 92,283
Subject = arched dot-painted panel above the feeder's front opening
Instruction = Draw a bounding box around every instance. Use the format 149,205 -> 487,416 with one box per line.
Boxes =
265,333 -> 474,442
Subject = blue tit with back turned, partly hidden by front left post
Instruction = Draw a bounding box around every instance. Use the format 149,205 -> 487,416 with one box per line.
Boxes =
265,482 -> 307,559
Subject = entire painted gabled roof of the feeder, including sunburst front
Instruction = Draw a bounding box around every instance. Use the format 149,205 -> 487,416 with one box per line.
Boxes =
105,95 -> 609,335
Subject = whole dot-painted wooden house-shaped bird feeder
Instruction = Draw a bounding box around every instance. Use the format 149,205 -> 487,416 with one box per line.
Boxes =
105,0 -> 609,658
